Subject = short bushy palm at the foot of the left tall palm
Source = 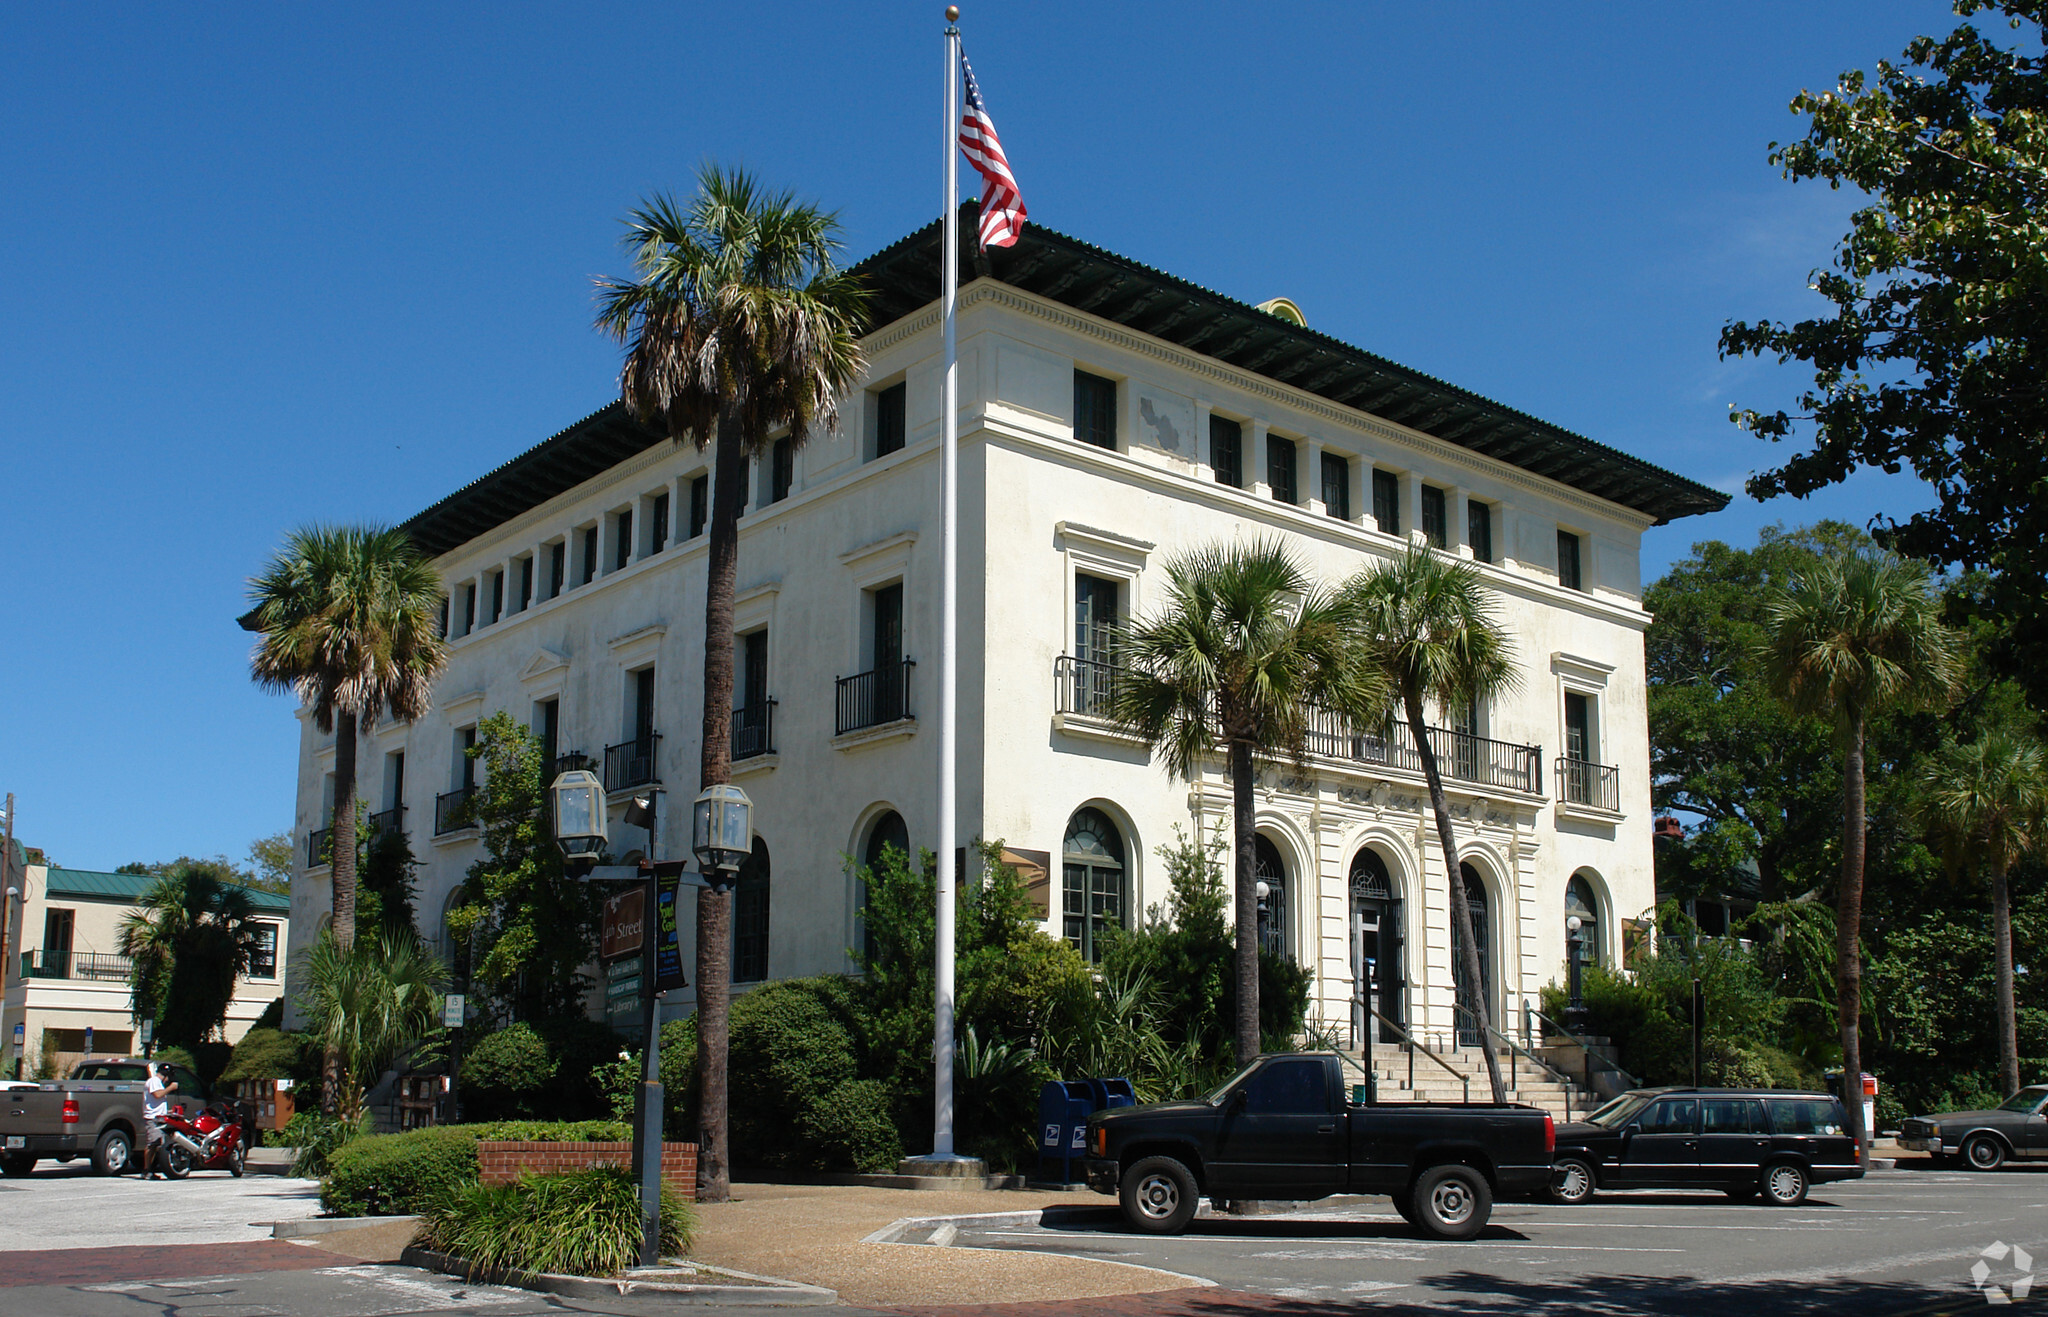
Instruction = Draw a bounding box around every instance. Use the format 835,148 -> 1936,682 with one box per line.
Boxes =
299,928 -> 449,1120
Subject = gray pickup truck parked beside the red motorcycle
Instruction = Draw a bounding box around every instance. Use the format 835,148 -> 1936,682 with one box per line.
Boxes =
0,1057 -> 207,1176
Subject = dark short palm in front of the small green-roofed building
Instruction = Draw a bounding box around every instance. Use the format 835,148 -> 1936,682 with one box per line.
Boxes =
119,864 -> 258,1047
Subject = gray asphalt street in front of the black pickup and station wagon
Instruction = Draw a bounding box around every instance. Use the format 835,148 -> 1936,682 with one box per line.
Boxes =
952,1167 -> 2048,1317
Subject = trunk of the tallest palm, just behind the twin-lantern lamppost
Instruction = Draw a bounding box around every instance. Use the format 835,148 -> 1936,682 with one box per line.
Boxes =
696,418 -> 748,1202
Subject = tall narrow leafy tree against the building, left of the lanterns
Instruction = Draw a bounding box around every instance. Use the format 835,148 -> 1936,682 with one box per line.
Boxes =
449,711 -> 602,1024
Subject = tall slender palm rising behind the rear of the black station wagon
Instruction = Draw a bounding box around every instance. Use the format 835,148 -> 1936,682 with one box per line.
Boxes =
1763,549 -> 1960,1159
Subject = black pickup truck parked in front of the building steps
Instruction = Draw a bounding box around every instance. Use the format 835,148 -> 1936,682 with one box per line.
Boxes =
1083,1053 -> 1556,1239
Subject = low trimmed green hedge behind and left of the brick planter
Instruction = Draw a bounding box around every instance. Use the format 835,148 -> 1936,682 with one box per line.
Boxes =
319,1120 -> 633,1217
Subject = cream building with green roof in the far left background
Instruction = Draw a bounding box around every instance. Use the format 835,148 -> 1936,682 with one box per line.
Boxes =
0,864 -> 291,1075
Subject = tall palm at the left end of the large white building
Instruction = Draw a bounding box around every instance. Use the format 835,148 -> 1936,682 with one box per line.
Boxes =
250,526 -> 449,1116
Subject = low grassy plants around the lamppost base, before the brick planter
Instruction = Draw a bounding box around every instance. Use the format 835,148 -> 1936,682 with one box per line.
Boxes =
418,1165 -> 696,1276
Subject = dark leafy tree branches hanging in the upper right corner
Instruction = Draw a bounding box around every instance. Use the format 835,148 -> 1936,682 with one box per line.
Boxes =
1720,0 -> 2048,707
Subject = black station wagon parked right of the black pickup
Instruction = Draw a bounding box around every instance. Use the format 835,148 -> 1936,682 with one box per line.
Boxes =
1550,1088 -> 1864,1206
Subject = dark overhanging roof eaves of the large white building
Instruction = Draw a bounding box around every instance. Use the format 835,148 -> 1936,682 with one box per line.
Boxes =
387,203 -> 1729,561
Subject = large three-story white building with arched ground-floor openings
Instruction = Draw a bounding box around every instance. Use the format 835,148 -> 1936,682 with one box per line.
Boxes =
276,223 -> 1726,1032
